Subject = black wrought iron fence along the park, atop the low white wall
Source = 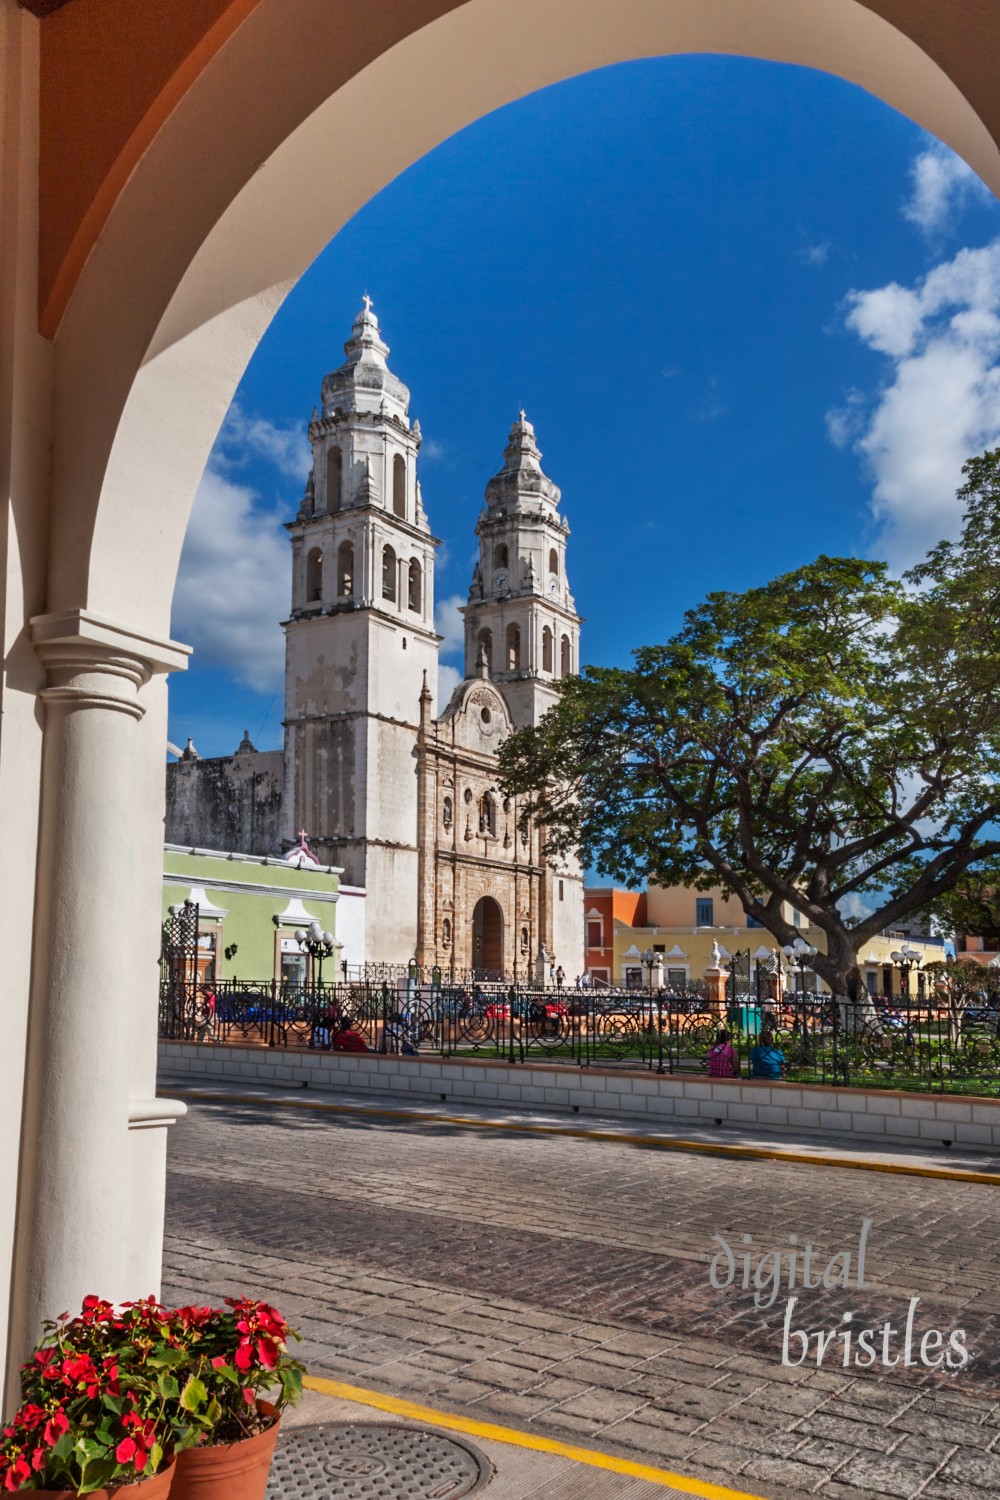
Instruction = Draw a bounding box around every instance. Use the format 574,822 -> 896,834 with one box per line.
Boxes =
160,975 -> 1000,1095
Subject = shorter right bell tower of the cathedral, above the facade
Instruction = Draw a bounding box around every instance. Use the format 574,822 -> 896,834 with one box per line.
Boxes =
465,411 -> 580,729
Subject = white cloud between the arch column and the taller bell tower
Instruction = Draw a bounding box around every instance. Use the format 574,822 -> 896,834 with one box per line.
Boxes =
171,468 -> 291,693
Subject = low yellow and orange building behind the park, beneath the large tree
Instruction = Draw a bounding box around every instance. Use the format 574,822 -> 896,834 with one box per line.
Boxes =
585,885 -> 945,998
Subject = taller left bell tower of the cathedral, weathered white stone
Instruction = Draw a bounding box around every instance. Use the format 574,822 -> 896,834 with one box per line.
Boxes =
283,297 -> 439,962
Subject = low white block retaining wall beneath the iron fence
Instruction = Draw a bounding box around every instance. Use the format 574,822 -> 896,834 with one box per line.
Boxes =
159,1041 -> 1000,1151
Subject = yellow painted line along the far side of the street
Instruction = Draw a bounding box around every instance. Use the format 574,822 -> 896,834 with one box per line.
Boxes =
169,1089 -> 1000,1188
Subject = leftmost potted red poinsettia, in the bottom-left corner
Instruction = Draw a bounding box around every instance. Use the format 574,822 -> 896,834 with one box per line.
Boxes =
0,1298 -> 174,1500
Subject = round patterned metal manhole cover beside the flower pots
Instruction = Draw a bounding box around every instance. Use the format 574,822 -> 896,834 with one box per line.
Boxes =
267,1422 -> 490,1500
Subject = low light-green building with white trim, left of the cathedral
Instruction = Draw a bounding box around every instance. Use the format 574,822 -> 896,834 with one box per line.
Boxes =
162,839 -> 350,984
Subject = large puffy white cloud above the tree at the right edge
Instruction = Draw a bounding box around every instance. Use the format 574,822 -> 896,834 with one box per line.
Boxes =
828,240 -> 1000,569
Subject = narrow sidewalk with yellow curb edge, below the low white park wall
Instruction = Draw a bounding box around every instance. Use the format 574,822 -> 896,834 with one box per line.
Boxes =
157,1074 -> 1000,1187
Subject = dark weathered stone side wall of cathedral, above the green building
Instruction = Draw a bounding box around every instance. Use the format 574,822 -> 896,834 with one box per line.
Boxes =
166,750 -> 283,855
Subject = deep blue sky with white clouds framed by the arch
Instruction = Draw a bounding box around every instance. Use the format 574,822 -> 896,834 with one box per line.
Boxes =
169,57 -> 1000,755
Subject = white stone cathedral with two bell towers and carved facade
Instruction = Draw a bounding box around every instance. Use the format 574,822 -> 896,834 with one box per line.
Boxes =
166,297 -> 583,980
